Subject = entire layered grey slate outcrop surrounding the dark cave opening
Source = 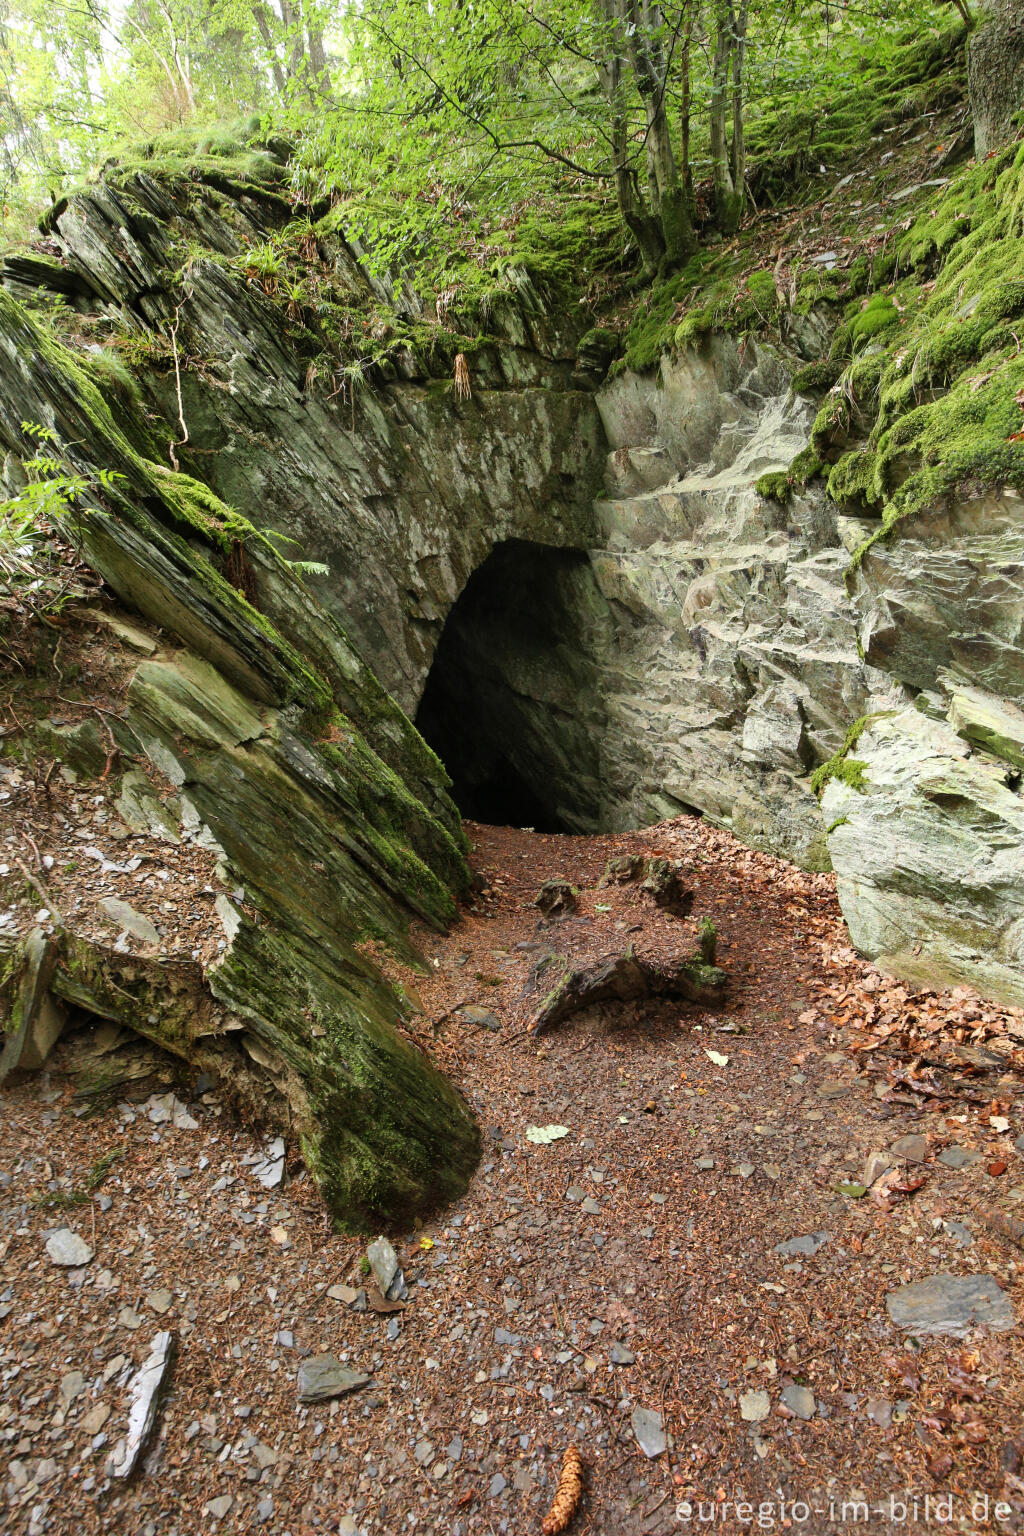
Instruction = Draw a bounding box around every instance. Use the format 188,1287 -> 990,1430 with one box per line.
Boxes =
0,138 -> 1024,1093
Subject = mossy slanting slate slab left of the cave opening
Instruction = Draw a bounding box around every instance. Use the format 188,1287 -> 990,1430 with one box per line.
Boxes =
0,288 -> 479,1227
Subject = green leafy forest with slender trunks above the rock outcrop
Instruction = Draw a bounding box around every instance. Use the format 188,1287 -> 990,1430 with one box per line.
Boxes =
0,0 -> 972,276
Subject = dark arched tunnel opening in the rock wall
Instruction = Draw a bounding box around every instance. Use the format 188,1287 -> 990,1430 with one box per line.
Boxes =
416,539 -> 608,833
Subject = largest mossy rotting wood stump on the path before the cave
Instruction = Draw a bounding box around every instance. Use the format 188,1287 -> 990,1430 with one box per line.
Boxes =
524,919 -> 726,1035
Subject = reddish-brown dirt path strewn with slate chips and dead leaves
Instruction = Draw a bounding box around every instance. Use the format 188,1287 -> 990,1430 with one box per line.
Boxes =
0,819 -> 1024,1536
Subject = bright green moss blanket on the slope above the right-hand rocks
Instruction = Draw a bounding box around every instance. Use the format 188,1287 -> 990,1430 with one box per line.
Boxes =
814,139 -> 1024,568
